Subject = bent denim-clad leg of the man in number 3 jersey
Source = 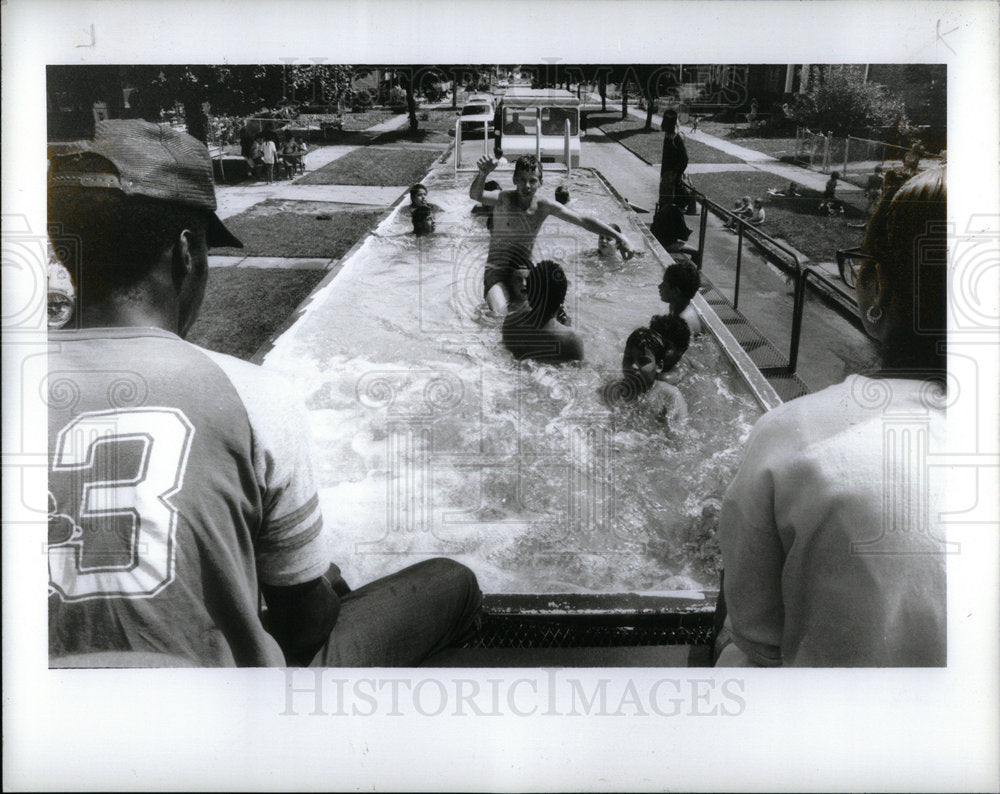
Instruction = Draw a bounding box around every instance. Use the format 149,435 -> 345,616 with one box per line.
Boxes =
311,558 -> 483,667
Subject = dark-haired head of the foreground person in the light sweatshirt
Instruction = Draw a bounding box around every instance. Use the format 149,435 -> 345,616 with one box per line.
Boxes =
862,166 -> 948,376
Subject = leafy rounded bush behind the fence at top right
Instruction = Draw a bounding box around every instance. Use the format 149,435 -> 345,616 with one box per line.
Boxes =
791,65 -> 906,136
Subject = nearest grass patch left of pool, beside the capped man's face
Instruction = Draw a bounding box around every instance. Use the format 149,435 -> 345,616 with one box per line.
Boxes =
187,267 -> 326,359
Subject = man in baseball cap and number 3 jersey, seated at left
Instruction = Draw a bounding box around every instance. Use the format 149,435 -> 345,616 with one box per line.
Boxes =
47,120 -> 481,667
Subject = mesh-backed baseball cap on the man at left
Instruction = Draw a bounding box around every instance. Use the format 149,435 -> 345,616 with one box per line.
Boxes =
49,119 -> 243,248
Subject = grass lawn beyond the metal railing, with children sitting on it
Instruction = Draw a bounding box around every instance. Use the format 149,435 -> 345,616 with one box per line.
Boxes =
691,171 -> 865,262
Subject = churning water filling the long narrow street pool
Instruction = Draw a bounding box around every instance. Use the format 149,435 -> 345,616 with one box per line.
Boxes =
263,166 -> 762,593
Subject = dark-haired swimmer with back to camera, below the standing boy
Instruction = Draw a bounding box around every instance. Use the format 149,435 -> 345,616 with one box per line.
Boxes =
501,259 -> 583,363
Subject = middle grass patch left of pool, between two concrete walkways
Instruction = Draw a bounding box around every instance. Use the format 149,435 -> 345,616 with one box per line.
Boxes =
212,201 -> 384,259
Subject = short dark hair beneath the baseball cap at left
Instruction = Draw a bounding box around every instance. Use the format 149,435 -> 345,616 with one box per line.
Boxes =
48,187 -> 208,301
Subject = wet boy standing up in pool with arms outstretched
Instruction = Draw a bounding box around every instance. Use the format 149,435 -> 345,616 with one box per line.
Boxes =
469,154 -> 635,314
